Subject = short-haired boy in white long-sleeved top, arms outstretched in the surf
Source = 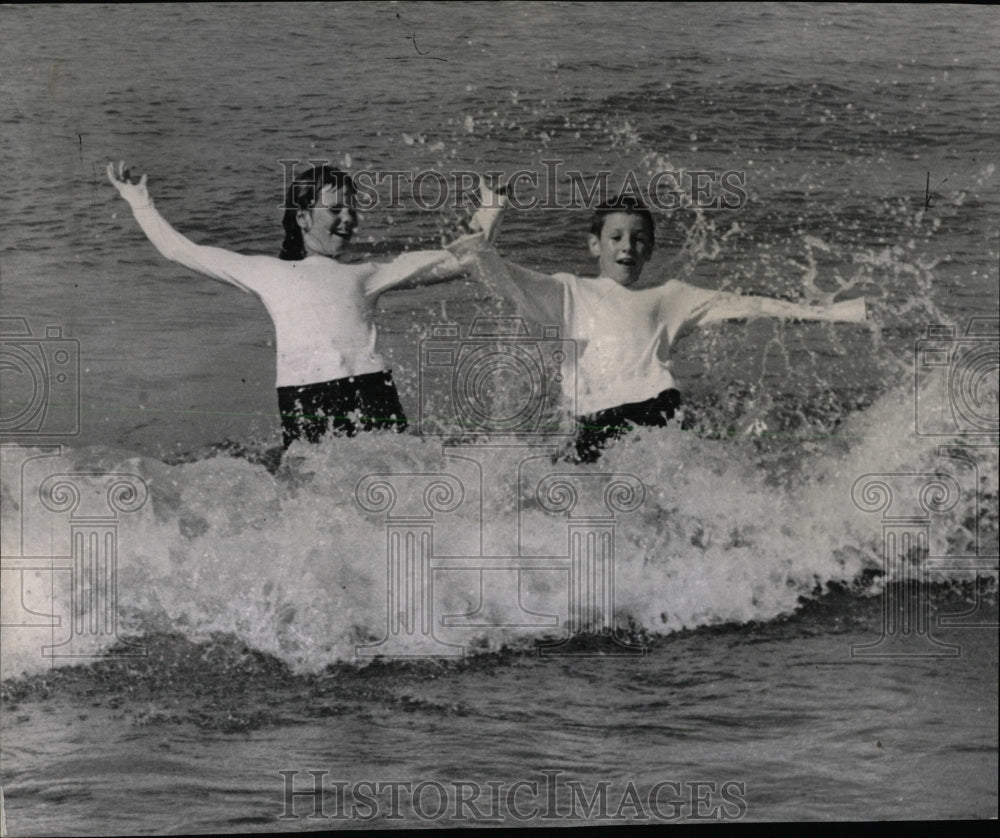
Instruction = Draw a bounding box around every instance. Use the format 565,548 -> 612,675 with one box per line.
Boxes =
477,196 -> 865,462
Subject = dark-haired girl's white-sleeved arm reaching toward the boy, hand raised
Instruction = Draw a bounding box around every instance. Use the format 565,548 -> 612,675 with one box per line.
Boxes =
365,178 -> 507,295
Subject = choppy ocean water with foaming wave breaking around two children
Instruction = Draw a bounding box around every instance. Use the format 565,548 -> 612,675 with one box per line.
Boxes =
0,3 -> 1000,835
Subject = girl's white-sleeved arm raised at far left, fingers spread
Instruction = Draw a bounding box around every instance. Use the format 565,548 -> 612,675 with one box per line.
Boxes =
108,162 -> 267,293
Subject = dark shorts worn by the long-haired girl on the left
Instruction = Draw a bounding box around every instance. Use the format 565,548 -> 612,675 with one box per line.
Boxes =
278,370 -> 406,448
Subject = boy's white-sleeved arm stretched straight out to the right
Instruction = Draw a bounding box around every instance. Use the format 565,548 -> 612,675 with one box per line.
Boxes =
664,281 -> 867,339
